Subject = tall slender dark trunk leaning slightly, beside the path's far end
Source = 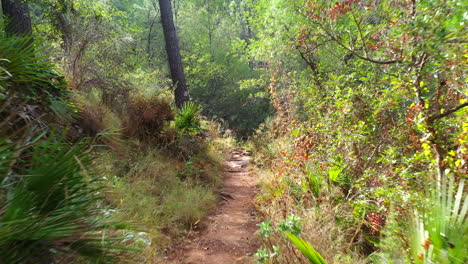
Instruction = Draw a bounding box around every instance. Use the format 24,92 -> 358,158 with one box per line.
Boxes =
159,0 -> 189,108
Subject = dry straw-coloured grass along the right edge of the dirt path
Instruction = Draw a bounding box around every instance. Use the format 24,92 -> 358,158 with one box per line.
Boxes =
255,138 -> 366,263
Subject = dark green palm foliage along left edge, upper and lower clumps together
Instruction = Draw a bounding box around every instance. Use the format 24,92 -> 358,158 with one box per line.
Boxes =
0,32 -> 126,263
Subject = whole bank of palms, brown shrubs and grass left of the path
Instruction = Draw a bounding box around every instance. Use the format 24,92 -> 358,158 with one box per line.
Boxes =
0,30 -> 234,263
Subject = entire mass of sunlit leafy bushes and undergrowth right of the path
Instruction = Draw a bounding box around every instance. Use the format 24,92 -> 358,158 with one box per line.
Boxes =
247,1 -> 468,263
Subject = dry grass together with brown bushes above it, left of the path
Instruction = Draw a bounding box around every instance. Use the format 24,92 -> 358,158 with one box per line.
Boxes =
70,85 -> 233,263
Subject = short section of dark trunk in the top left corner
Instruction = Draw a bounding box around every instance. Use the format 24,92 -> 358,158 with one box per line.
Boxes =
2,0 -> 32,36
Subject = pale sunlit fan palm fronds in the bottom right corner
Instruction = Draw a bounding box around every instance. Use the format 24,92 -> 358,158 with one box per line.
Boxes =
410,176 -> 468,263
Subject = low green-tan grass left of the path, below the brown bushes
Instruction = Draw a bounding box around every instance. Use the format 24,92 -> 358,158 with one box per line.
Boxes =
95,132 -> 234,263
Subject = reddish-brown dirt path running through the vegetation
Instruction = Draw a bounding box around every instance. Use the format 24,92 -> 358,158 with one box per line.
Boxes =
169,150 -> 257,264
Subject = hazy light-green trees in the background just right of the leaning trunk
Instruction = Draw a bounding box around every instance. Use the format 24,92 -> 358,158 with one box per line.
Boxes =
177,0 -> 272,138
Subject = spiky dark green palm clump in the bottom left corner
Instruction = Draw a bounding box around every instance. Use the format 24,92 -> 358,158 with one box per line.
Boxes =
0,123 -> 125,263
